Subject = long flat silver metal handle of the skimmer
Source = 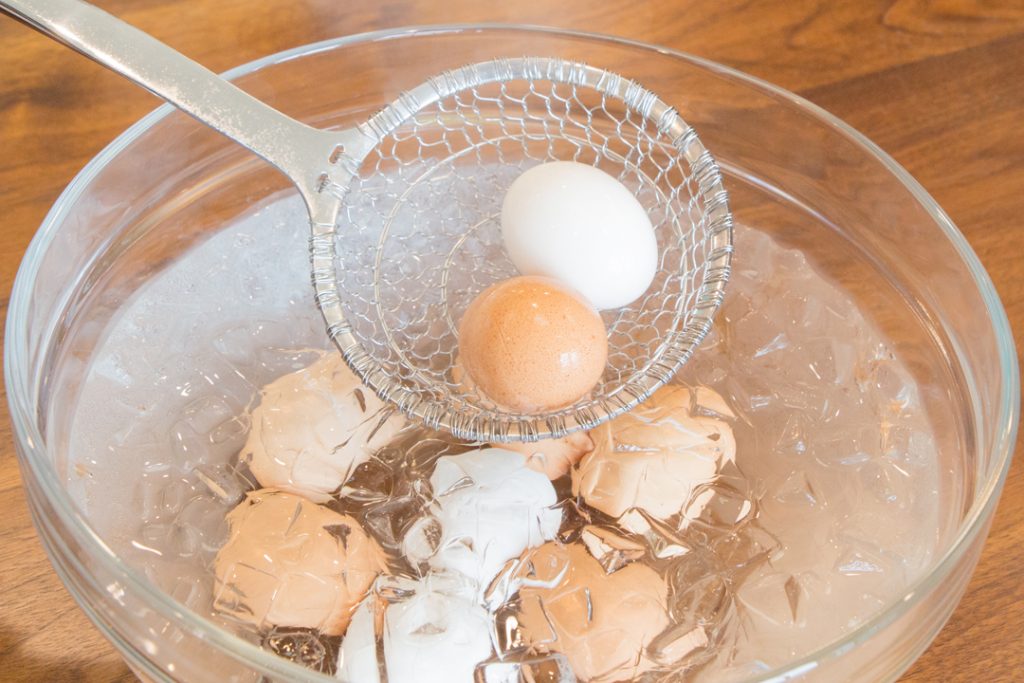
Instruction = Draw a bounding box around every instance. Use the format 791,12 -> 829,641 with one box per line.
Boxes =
0,0 -> 336,200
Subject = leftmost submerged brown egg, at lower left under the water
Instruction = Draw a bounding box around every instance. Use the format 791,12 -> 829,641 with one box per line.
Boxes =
214,489 -> 385,636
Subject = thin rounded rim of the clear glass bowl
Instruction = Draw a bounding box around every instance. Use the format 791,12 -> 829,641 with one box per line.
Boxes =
4,24 -> 1020,683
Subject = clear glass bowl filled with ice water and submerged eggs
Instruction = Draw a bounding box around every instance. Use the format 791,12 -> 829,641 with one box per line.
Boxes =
5,28 -> 1018,682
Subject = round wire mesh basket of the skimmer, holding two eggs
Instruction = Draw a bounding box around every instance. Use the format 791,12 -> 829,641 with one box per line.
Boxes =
315,59 -> 731,441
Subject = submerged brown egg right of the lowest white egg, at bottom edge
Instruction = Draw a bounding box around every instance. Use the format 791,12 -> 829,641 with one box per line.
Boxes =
519,543 -> 669,683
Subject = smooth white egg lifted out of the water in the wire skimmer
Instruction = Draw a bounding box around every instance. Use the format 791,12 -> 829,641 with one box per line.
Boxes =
502,161 -> 657,309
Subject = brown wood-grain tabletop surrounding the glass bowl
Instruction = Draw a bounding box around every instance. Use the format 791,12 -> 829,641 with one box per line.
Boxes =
0,0 -> 1024,681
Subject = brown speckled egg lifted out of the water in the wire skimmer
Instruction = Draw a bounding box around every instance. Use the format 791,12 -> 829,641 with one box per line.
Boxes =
459,276 -> 608,413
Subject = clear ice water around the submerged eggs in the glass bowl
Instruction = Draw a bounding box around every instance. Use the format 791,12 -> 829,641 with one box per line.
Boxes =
68,193 -> 940,681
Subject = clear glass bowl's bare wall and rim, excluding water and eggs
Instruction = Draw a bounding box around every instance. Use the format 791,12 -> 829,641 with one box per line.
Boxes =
5,26 -> 1019,681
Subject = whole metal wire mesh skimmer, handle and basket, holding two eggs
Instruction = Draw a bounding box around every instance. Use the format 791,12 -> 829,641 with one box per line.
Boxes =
0,0 -> 732,442
